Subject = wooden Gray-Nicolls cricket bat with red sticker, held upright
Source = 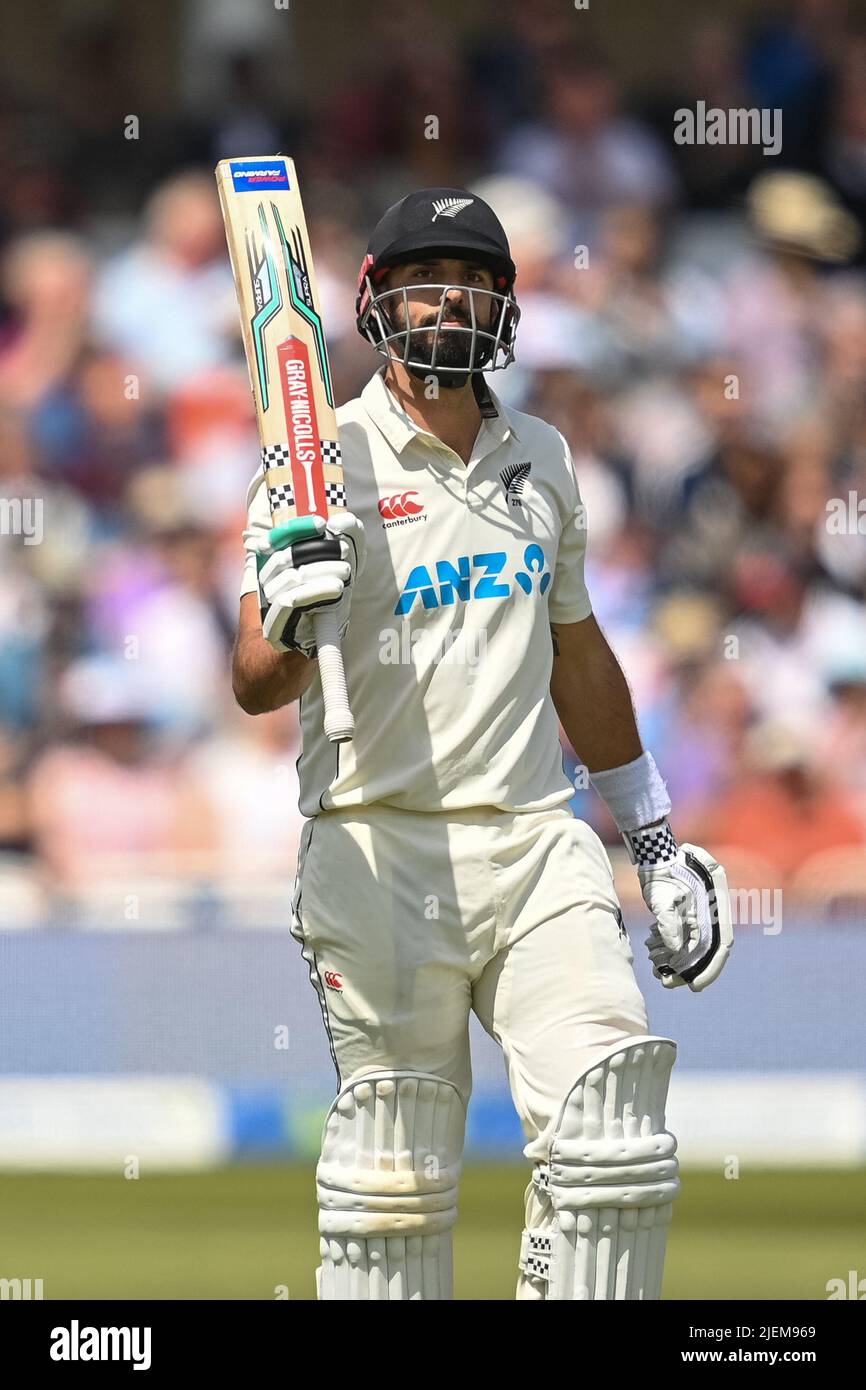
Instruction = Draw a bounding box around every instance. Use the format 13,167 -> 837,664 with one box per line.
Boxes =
217,156 -> 354,744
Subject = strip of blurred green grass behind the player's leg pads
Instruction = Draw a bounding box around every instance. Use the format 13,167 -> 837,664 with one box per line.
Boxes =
0,1165 -> 866,1300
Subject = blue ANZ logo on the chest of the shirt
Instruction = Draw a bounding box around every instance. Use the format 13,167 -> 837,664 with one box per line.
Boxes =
393,543 -> 552,617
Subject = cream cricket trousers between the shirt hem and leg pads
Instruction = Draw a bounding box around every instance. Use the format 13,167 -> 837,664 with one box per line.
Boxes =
292,806 -> 649,1162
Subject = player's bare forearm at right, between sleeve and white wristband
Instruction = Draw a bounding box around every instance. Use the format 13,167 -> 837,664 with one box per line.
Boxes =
550,619 -> 642,773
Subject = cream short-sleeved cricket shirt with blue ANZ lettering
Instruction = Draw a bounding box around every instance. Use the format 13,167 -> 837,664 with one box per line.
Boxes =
240,367 -> 591,816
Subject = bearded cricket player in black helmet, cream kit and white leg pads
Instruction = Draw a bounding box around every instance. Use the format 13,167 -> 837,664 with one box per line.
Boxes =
234,188 -> 731,1300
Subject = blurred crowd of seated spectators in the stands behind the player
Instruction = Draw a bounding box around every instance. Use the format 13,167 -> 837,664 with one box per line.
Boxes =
0,0 -> 866,891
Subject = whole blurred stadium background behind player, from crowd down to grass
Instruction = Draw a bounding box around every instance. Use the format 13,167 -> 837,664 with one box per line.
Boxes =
0,0 -> 866,1298
